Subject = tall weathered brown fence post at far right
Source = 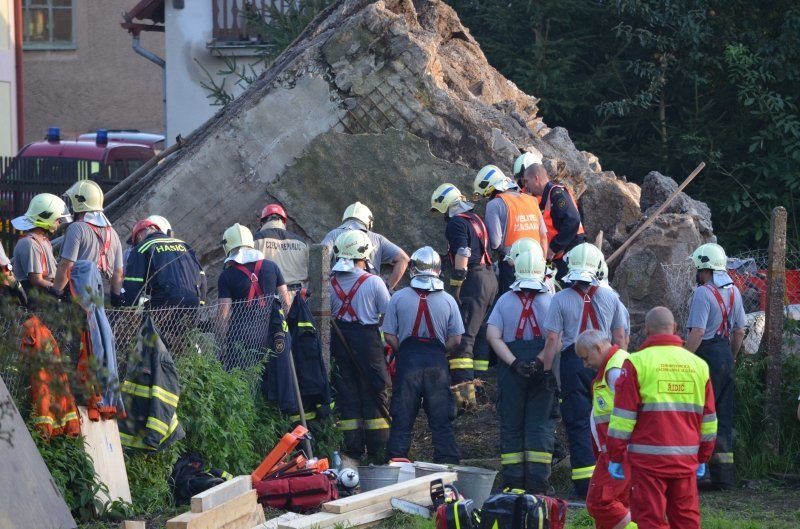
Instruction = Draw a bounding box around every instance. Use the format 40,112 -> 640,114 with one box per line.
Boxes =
763,207 -> 786,454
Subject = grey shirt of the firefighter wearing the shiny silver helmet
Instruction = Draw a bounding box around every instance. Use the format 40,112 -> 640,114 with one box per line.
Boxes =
381,287 -> 464,344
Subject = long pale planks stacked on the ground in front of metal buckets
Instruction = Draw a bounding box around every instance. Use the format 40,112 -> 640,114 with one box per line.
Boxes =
277,472 -> 457,529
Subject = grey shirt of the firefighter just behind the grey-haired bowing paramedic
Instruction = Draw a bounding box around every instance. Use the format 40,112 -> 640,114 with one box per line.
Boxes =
544,280 -> 625,351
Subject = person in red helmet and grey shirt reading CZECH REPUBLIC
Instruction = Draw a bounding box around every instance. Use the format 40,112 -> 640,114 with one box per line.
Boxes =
253,204 -> 308,298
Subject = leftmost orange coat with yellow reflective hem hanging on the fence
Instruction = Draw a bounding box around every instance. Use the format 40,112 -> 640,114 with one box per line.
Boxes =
20,316 -> 81,437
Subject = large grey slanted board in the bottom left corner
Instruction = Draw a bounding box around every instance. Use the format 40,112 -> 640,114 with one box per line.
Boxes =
0,377 -> 77,529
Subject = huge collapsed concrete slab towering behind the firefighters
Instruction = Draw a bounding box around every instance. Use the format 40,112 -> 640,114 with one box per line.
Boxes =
108,0 -> 712,330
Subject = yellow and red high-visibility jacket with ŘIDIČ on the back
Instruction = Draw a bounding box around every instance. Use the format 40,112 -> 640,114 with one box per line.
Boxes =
608,345 -> 717,475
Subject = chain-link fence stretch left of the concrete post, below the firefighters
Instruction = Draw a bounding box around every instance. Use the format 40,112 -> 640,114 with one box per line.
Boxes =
0,297 -> 284,399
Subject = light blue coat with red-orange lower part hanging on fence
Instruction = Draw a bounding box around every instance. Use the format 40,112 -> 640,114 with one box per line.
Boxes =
69,260 -> 125,421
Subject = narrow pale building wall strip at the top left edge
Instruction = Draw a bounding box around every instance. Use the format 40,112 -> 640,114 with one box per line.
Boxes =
0,0 -> 18,156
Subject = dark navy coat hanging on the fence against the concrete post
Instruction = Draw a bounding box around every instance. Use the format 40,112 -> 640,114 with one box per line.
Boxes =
287,295 -> 331,420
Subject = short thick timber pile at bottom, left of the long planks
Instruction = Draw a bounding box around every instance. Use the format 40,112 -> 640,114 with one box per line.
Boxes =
167,476 -> 264,529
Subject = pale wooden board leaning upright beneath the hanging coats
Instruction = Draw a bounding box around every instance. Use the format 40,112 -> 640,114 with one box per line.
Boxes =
78,406 -> 131,503
